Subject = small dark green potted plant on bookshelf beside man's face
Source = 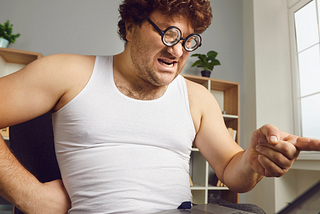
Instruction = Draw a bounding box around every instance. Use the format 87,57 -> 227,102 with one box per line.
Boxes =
191,51 -> 221,77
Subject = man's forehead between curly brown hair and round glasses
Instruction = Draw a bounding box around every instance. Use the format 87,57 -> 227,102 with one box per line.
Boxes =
149,11 -> 194,34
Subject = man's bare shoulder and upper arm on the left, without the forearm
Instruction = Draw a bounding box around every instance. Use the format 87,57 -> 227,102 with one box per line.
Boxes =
0,54 -> 95,127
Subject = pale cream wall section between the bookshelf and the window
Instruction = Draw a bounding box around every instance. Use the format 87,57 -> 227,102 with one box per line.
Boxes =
243,0 -> 293,213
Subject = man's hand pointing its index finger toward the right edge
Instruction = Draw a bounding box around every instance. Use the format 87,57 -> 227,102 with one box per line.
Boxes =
248,125 -> 320,177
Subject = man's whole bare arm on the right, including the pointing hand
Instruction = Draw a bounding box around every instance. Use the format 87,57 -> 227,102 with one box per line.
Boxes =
188,80 -> 320,192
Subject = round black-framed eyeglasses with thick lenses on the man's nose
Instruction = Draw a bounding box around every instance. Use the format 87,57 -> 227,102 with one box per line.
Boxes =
147,18 -> 202,52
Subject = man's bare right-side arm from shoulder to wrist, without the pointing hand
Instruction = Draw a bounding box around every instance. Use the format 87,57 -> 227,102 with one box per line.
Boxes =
187,82 -> 261,192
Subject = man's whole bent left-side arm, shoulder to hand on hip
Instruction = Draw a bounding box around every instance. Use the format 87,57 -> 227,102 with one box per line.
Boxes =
0,55 -> 93,214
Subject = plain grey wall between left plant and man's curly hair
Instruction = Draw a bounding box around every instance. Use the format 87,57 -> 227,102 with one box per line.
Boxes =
0,0 -> 123,56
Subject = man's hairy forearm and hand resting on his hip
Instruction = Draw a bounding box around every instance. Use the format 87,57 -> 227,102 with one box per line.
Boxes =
0,135 -> 70,214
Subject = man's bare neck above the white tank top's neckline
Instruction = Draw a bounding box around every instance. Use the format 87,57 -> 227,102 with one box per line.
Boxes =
113,52 -> 168,100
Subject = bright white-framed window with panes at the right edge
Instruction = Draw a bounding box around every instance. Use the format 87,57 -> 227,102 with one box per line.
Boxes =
288,0 -> 320,140
